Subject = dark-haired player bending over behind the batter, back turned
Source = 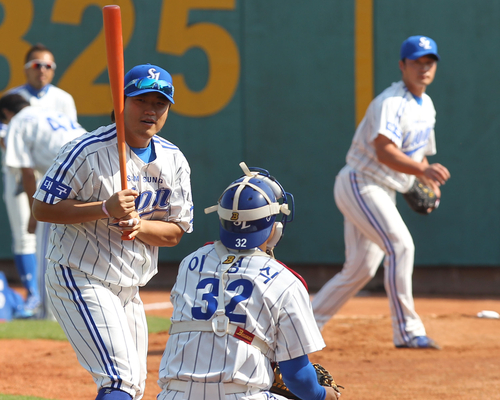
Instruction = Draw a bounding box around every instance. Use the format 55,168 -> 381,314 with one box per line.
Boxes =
0,94 -> 86,318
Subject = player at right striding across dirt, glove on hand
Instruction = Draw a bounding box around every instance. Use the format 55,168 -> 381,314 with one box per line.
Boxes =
312,36 -> 450,348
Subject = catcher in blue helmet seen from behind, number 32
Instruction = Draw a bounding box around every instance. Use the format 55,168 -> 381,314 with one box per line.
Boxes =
157,163 -> 340,400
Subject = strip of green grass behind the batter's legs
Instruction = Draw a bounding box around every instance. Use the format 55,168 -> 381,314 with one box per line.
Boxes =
0,316 -> 170,340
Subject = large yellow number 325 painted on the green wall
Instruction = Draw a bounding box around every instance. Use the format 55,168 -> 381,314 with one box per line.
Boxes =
0,0 -> 240,117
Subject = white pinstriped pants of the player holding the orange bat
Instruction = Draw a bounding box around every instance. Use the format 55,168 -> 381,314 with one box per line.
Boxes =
46,261 -> 148,400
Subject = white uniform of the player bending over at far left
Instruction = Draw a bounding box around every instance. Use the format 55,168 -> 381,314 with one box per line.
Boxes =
4,106 -> 86,318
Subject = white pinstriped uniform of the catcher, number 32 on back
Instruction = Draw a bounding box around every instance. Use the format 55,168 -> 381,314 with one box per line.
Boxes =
158,242 -> 325,400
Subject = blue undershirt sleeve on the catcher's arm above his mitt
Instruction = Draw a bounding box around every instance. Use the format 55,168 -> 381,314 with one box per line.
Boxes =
279,354 -> 326,400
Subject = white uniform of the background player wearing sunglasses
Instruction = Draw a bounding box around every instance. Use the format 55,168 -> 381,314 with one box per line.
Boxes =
0,84 -> 77,254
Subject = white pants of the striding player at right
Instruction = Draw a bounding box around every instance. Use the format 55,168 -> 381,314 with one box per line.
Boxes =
312,166 -> 426,345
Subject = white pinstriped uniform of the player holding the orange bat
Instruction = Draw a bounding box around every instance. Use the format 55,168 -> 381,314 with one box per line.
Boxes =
35,124 -> 193,399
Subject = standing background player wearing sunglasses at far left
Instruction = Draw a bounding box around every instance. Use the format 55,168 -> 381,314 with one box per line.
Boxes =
0,44 -> 77,317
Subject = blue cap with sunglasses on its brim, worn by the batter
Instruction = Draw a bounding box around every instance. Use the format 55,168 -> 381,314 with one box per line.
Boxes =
124,64 -> 174,104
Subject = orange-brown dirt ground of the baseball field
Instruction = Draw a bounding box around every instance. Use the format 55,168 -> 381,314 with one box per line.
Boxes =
0,291 -> 500,400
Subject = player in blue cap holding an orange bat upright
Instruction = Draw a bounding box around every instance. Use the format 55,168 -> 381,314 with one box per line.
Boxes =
33,64 -> 193,400
